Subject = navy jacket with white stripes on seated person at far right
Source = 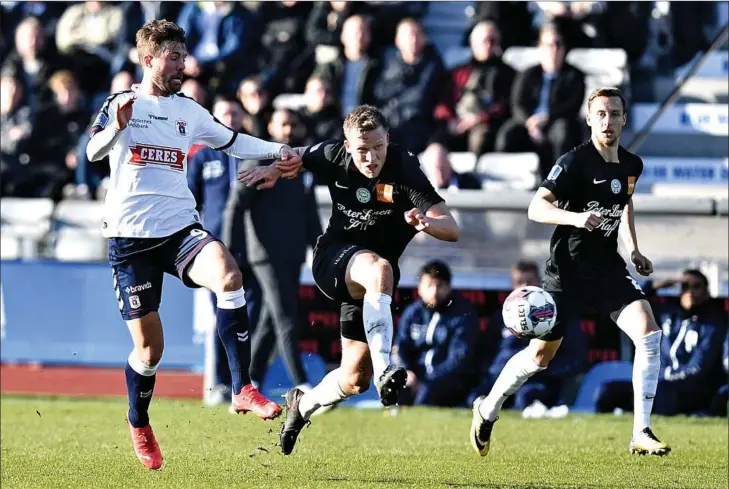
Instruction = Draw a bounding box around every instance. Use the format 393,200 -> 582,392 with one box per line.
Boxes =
659,302 -> 726,388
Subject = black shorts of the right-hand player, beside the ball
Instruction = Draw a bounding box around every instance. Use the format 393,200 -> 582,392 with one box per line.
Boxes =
539,269 -> 645,341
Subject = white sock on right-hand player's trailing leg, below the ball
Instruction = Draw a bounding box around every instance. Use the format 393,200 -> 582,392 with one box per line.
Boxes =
478,348 -> 547,421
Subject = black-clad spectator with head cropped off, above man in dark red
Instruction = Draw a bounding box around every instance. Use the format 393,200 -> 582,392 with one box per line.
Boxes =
468,1 -> 537,50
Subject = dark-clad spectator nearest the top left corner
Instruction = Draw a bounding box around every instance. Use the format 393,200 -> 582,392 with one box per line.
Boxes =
2,17 -> 62,110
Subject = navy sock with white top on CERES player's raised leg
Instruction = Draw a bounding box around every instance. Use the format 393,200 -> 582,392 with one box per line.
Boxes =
215,288 -> 251,395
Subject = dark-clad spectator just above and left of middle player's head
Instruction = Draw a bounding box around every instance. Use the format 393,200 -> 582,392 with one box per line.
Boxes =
301,75 -> 344,145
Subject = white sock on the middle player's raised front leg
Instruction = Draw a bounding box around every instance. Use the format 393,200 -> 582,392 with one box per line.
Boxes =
362,292 -> 393,380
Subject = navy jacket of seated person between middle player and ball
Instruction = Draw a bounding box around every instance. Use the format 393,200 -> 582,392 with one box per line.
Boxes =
397,294 -> 478,382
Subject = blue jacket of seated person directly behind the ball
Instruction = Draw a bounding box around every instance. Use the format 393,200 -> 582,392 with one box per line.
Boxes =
489,311 -> 588,381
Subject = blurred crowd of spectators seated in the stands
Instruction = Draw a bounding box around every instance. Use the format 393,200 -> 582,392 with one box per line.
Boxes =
0,1 -> 715,200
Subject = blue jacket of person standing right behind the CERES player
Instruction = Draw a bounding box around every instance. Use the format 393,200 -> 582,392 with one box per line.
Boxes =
187,147 -> 238,239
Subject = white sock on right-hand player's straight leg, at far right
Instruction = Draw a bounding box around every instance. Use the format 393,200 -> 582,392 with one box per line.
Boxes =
633,330 -> 662,434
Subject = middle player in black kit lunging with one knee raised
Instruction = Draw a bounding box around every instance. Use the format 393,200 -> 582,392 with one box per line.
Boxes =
240,105 -> 458,455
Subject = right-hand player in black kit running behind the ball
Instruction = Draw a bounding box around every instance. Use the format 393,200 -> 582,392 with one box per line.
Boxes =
469,88 -> 671,456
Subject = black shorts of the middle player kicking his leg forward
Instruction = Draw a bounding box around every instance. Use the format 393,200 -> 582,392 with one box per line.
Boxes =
312,241 -> 400,343
